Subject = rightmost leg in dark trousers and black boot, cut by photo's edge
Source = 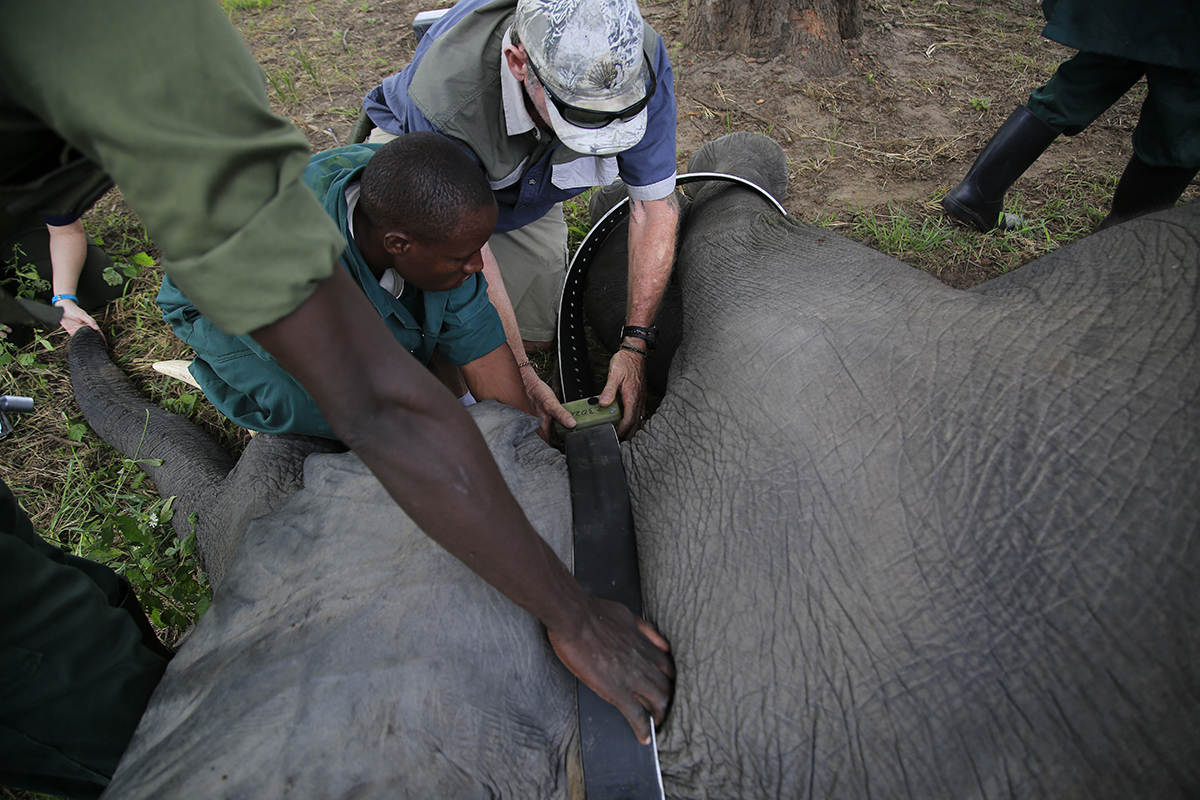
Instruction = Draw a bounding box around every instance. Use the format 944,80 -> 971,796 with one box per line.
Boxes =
1097,65 -> 1200,230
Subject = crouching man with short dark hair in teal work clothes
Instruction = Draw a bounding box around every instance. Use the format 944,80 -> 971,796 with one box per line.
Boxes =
158,132 -> 532,439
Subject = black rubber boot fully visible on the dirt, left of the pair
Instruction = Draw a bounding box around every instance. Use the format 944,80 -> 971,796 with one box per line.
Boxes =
942,106 -> 1061,233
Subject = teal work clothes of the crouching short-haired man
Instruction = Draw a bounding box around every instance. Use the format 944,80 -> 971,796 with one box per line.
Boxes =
158,144 -> 505,439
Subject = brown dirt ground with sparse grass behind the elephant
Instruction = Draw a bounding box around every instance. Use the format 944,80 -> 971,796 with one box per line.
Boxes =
225,0 -> 1195,287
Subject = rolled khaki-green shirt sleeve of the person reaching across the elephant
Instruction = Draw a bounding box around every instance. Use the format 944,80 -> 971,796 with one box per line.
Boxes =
0,0 -> 346,335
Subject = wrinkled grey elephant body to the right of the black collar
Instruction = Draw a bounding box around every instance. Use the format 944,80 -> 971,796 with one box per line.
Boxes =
625,159 -> 1200,798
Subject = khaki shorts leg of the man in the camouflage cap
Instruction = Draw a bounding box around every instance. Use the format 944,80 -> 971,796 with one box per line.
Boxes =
488,203 -> 566,351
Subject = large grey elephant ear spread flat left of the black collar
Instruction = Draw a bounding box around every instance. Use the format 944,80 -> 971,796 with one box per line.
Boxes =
108,402 -> 575,800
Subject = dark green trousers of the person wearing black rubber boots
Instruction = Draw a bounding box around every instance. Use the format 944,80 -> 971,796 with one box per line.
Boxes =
1028,50 -> 1200,169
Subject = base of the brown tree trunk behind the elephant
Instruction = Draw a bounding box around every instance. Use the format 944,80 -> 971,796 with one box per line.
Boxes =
684,0 -> 863,74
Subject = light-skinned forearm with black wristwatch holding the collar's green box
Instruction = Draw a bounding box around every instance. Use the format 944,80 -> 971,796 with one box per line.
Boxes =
600,192 -> 679,439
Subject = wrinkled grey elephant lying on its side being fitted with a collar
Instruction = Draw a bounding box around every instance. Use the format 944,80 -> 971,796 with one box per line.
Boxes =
72,133 -> 1200,800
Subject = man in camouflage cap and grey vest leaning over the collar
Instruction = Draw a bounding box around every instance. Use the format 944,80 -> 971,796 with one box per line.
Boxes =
364,0 -> 678,437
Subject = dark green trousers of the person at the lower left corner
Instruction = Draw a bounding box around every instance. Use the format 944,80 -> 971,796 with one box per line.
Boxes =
0,481 -> 167,798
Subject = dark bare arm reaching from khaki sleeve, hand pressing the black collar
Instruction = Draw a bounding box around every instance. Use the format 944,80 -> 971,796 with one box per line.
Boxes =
252,269 -> 674,741
